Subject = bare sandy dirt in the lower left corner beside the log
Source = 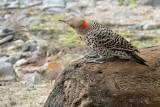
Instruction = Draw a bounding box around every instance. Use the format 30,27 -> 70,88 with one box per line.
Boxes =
0,82 -> 53,107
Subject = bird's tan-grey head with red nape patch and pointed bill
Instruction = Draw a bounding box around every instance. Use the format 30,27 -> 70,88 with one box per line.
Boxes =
59,18 -> 88,30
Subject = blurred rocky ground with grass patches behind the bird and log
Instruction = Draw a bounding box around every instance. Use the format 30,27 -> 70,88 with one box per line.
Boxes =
0,0 -> 160,107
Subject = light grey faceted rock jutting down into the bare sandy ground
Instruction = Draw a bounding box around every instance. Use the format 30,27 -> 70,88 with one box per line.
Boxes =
22,72 -> 41,88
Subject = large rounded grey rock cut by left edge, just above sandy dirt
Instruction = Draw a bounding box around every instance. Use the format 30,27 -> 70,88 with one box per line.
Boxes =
0,62 -> 16,81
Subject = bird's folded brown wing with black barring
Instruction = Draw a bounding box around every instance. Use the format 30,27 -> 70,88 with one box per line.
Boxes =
98,32 -> 138,53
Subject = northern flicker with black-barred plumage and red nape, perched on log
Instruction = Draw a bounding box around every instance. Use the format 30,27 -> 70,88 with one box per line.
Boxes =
59,18 -> 147,65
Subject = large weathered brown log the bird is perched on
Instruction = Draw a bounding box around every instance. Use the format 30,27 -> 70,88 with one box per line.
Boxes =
44,46 -> 160,107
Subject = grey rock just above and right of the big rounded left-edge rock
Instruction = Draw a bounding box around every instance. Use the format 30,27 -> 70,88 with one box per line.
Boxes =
7,53 -> 21,64
